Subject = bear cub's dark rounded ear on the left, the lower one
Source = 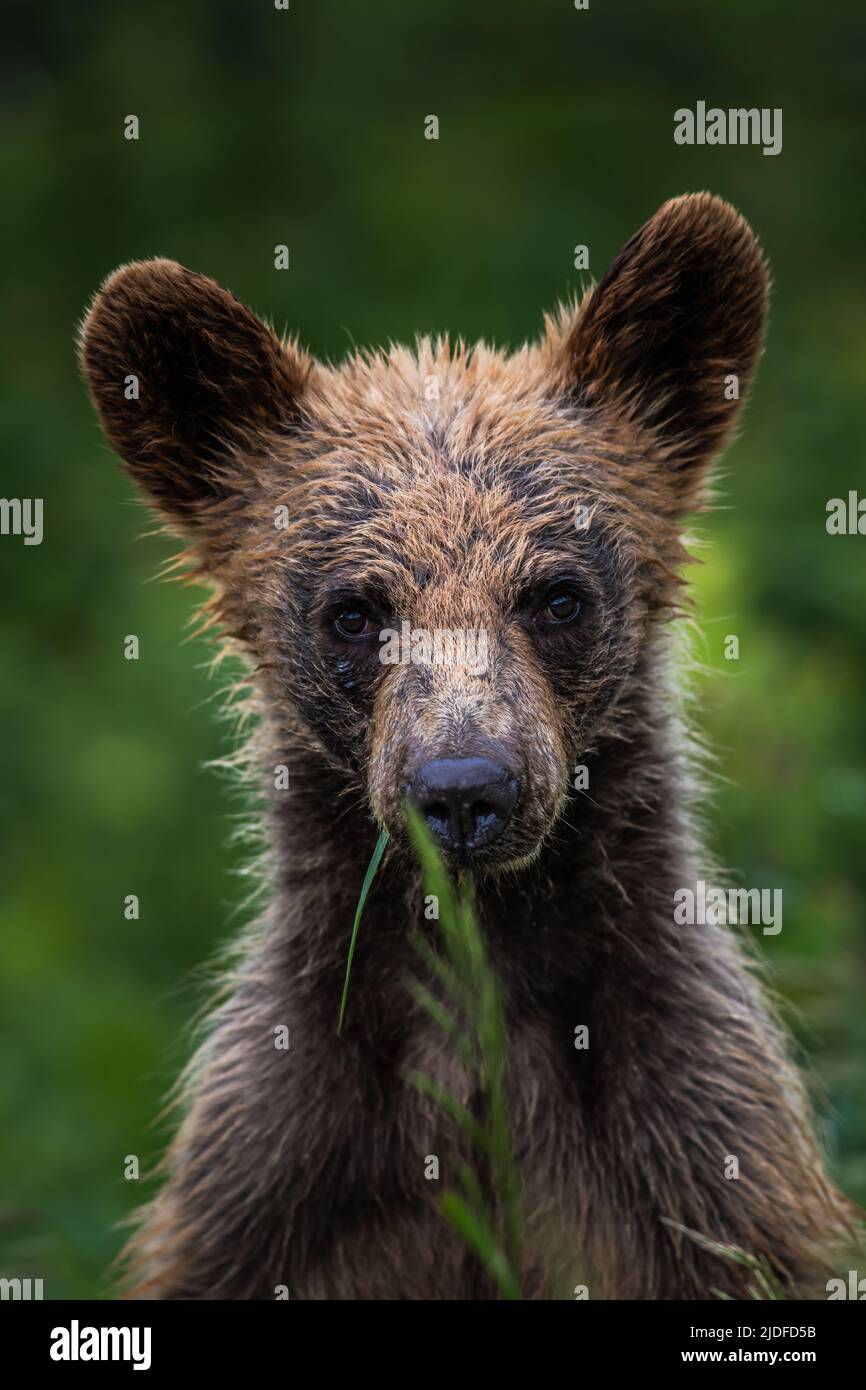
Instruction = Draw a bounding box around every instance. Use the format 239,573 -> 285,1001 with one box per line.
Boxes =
81,260 -> 309,531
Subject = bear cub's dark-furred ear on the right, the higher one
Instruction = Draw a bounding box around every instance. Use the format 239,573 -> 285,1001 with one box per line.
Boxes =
566,193 -> 767,509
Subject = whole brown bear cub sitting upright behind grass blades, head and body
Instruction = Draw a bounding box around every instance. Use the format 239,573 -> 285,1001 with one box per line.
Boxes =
79,193 -> 856,1300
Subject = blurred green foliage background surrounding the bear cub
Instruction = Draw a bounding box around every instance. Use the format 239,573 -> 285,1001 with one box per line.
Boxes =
0,0 -> 866,1297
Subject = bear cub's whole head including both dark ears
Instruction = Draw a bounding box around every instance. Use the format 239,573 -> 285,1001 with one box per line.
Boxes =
82,195 -> 767,873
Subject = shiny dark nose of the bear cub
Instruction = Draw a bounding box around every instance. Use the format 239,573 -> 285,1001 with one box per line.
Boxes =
406,758 -> 520,855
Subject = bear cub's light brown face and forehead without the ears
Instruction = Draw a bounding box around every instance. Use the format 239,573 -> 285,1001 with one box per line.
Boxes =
263,364 -> 649,869
